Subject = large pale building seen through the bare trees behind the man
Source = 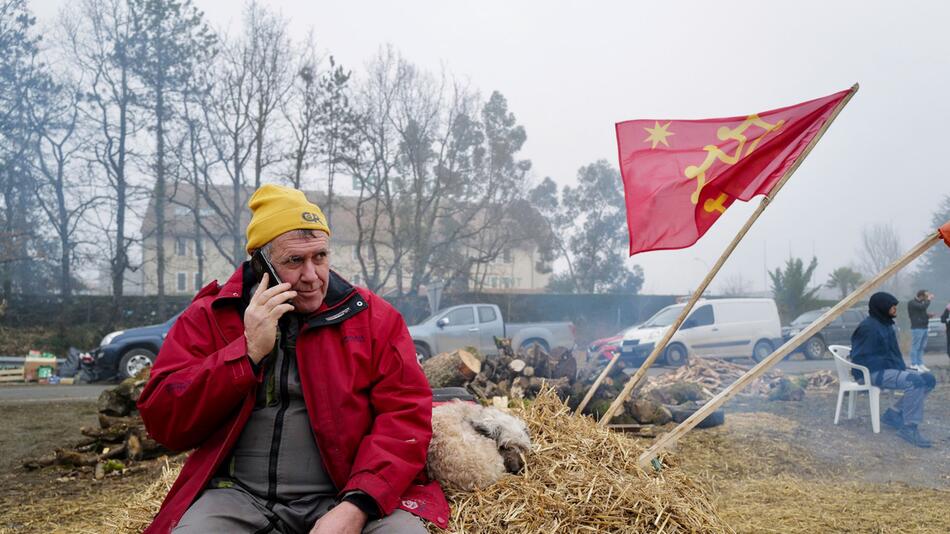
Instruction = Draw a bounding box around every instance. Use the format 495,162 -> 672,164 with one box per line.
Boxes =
140,186 -> 551,295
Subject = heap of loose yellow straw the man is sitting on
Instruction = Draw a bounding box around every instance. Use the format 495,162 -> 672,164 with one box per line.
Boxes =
106,389 -> 733,534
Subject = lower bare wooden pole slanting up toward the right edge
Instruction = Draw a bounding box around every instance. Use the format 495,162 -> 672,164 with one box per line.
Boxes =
638,230 -> 950,467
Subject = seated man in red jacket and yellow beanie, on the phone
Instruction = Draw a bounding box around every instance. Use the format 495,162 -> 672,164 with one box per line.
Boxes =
138,184 -> 449,534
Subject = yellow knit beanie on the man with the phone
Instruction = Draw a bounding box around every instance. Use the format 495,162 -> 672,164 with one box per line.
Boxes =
247,184 -> 330,254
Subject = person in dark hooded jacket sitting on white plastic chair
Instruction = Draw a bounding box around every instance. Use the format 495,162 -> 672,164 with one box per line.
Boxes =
851,292 -> 937,447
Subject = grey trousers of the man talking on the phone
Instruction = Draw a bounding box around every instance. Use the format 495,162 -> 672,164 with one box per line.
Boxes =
173,486 -> 426,534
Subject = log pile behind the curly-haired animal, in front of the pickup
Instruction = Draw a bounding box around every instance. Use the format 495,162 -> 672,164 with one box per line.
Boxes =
422,338 -> 577,401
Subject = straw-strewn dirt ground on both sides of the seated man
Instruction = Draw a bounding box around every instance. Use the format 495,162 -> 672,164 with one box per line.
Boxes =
0,370 -> 950,533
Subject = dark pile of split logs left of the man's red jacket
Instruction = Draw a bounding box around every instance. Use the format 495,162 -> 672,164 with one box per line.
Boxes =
23,369 -> 171,479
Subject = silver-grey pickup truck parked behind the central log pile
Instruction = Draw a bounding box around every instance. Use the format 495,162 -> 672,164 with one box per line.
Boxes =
409,304 -> 576,361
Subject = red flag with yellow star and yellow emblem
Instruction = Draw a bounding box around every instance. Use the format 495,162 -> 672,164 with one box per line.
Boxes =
617,89 -> 855,256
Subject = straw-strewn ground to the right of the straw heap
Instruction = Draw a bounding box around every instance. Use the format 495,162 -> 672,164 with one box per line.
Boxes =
675,372 -> 950,534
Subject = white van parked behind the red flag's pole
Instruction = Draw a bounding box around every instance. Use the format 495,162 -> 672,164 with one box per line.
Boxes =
620,298 -> 782,367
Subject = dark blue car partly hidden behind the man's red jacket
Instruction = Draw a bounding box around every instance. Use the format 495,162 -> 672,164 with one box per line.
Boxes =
91,313 -> 181,380
